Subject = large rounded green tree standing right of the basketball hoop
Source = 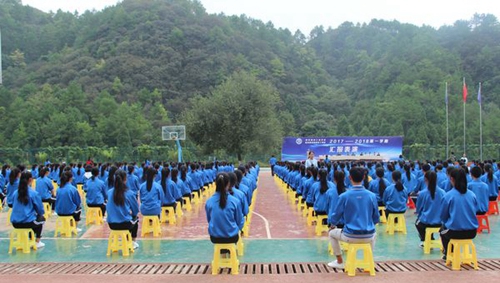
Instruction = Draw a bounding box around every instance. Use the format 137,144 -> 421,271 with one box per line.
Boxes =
183,72 -> 282,162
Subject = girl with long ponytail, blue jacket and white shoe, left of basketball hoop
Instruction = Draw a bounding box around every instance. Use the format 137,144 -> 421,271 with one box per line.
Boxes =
106,169 -> 139,249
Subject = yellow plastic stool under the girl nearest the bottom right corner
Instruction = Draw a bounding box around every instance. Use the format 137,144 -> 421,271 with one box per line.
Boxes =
446,239 -> 479,270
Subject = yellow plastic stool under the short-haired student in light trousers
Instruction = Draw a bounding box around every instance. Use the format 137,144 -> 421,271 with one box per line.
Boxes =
345,243 -> 375,276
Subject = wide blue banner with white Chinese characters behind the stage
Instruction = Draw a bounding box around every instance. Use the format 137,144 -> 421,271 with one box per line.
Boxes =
281,136 -> 403,161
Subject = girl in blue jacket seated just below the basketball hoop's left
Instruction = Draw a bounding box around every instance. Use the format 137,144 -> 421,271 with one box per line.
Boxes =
139,168 -> 164,216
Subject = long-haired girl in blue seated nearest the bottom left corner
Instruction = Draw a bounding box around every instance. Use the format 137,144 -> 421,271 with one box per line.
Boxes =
10,172 -> 45,248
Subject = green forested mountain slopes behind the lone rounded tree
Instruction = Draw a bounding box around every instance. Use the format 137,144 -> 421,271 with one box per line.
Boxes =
0,0 -> 500,160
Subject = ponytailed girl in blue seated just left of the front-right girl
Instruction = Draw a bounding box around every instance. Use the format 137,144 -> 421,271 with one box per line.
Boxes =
415,171 -> 445,247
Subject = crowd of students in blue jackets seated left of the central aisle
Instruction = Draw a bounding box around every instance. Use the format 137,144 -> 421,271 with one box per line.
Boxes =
0,162 -> 260,252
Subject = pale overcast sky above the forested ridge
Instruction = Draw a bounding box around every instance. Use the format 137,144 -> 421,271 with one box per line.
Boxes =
22,0 -> 500,34
